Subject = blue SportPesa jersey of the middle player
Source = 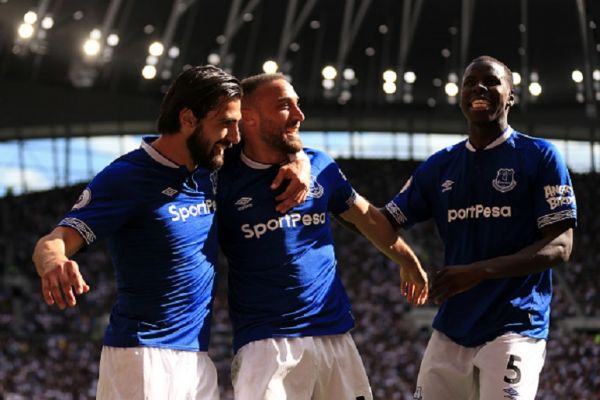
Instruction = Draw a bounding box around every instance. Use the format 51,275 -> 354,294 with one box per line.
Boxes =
217,149 -> 356,351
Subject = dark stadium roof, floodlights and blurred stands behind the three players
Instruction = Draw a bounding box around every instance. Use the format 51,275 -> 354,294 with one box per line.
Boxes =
0,0 -> 600,400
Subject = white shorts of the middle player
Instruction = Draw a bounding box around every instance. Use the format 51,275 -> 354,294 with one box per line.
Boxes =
231,333 -> 373,400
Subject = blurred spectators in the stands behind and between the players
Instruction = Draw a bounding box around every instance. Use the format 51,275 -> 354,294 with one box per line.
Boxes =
0,160 -> 600,400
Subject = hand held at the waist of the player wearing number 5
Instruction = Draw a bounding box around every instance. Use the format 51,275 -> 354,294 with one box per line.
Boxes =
429,265 -> 482,304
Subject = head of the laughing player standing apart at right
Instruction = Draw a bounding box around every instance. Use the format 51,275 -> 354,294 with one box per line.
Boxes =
460,60 -> 514,128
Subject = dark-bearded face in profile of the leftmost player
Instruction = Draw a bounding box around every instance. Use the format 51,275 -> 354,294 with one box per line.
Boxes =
187,98 -> 242,170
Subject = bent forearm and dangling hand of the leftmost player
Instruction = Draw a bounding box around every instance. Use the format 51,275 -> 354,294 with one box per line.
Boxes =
32,226 -> 90,310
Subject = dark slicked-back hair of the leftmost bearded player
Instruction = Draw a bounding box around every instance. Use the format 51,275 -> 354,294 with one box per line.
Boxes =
156,65 -> 242,134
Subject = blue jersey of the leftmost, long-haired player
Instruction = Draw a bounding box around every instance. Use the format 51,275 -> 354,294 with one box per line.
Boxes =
59,138 -> 218,351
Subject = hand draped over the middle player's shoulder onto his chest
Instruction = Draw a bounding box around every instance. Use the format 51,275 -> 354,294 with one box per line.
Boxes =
271,157 -> 310,214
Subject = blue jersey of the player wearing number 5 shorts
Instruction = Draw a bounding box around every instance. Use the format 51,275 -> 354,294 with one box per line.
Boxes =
386,127 -> 577,346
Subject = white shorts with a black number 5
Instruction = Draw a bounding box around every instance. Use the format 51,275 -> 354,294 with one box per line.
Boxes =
414,330 -> 546,400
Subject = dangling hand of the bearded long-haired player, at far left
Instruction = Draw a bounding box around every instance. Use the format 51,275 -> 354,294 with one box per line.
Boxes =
38,259 -> 90,310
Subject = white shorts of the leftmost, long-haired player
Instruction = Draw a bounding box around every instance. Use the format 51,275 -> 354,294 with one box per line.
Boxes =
96,346 -> 219,400
